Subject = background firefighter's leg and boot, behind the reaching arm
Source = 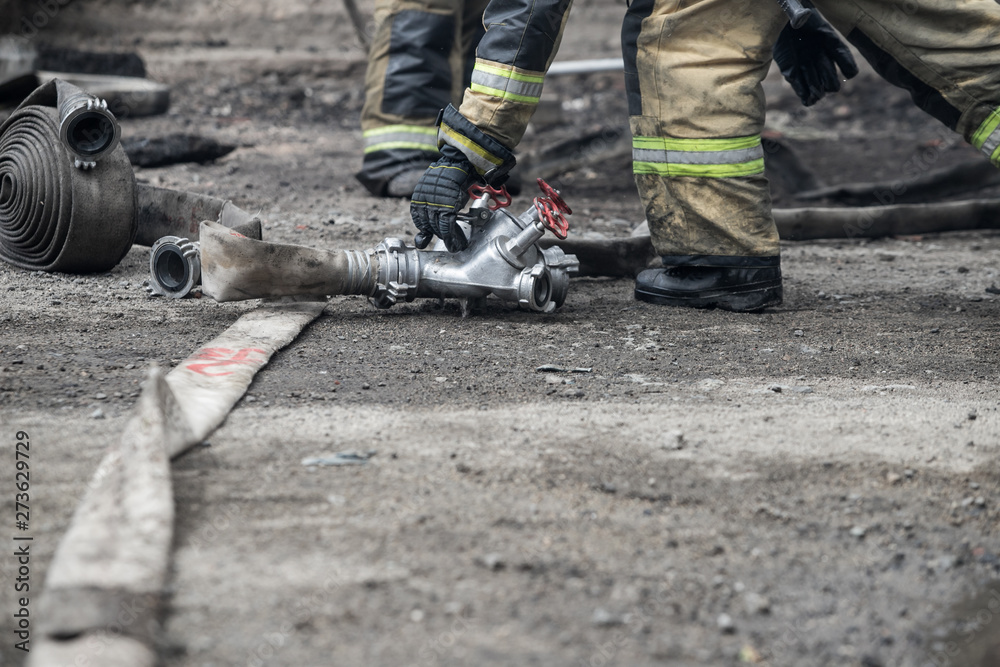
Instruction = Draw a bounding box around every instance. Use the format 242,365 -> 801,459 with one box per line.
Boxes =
358,0 -> 487,194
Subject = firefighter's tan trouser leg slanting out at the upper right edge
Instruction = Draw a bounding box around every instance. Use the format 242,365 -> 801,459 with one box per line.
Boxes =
815,0 -> 1000,166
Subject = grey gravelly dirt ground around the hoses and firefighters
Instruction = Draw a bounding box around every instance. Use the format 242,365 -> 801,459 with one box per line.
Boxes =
0,0 -> 1000,667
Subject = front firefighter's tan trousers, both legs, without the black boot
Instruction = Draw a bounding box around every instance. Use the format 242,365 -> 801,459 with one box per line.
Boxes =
622,0 -> 1000,265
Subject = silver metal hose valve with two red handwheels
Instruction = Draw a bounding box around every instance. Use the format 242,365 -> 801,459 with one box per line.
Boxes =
368,179 -> 580,313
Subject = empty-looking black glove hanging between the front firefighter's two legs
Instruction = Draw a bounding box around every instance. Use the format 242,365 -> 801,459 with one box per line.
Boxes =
774,9 -> 858,107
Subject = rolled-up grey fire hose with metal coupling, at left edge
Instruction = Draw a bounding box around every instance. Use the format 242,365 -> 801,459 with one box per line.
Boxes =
0,80 -> 137,273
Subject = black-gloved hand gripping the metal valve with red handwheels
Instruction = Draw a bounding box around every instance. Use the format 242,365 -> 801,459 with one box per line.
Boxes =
410,144 -> 480,252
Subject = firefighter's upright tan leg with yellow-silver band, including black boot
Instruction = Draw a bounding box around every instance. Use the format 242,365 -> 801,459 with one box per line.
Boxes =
622,0 -> 785,310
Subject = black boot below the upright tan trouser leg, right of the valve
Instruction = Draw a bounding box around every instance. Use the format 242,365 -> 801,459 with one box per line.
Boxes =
635,264 -> 782,313
